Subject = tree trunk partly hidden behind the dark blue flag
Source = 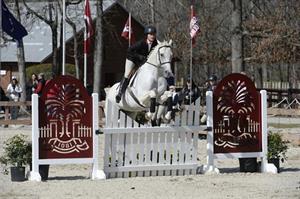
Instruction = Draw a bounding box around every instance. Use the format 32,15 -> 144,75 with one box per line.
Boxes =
15,0 -> 26,102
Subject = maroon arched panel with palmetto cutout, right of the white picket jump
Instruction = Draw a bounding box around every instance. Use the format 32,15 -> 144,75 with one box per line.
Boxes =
213,73 -> 262,153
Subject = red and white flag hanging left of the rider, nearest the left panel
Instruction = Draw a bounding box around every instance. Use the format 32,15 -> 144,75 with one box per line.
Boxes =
84,0 -> 94,54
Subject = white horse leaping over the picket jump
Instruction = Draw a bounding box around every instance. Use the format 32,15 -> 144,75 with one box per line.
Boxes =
106,40 -> 172,123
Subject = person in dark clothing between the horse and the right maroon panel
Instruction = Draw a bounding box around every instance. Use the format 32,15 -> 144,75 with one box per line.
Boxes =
179,77 -> 200,105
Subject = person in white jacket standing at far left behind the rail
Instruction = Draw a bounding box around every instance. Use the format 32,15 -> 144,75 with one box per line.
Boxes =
7,76 -> 23,119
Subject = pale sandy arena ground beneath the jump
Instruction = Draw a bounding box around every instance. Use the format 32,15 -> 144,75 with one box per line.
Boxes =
0,120 -> 300,199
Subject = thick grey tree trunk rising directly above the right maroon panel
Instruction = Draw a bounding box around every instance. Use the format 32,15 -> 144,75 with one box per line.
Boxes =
231,0 -> 243,73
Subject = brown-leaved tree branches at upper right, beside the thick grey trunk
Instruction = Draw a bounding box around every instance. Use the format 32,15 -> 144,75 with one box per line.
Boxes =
244,0 -> 300,85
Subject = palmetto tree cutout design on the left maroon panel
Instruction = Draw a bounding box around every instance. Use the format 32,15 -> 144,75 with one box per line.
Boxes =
45,84 -> 85,138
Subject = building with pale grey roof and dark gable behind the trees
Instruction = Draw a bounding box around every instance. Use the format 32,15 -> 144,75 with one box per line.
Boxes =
0,0 -> 144,88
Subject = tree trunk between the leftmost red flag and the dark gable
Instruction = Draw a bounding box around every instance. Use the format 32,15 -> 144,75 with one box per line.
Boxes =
93,0 -> 103,94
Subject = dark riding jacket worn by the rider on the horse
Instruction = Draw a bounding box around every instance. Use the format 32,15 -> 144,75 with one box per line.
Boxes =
127,39 -> 157,66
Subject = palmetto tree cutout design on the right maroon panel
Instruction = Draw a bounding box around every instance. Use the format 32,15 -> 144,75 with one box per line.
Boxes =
217,80 -> 255,136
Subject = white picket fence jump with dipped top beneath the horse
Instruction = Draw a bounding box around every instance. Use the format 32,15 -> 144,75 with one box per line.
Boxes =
102,99 -> 203,178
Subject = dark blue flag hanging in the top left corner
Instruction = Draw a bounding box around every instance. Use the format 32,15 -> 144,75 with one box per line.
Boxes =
1,0 -> 28,41
